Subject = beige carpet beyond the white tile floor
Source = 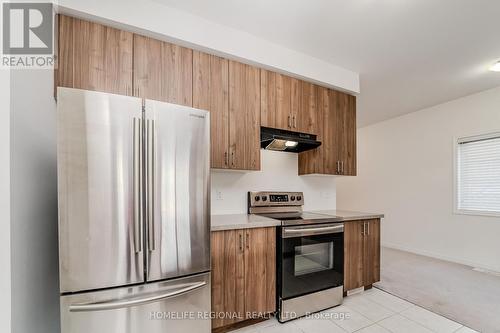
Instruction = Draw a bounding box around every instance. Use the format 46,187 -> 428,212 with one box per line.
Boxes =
375,248 -> 500,333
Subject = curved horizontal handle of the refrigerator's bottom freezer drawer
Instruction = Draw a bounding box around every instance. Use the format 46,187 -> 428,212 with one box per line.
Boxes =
69,281 -> 207,312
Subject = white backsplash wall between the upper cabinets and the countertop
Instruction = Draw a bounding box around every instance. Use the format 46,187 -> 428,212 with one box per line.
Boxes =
211,150 -> 336,214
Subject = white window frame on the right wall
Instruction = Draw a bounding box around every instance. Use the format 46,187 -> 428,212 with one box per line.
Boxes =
453,130 -> 500,217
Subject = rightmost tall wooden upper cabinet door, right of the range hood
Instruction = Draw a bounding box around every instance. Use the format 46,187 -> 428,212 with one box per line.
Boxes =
336,92 -> 356,176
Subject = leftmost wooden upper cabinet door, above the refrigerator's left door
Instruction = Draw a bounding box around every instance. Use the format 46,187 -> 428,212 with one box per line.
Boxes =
56,15 -> 133,95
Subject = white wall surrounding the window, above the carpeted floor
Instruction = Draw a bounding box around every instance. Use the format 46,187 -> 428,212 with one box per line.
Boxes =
337,88 -> 500,271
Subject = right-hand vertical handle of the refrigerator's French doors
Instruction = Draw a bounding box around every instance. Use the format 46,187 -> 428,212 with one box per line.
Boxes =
146,119 -> 156,251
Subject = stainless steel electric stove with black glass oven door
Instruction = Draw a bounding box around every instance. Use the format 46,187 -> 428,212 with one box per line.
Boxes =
248,192 -> 344,322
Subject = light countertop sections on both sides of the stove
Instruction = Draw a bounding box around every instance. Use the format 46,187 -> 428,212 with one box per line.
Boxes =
211,210 -> 384,231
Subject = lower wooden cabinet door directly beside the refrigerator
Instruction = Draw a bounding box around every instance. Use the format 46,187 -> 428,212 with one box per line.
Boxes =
211,230 -> 245,328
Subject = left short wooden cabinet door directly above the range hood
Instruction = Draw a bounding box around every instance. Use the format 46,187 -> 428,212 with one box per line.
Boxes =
260,69 -> 277,128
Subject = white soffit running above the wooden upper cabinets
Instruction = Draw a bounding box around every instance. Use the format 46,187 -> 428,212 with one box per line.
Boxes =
54,0 -> 359,93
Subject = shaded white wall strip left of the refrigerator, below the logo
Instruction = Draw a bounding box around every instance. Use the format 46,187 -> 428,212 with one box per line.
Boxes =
10,69 -> 59,333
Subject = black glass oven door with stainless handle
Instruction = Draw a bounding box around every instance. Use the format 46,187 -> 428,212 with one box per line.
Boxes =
278,223 -> 344,300
